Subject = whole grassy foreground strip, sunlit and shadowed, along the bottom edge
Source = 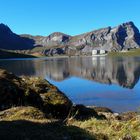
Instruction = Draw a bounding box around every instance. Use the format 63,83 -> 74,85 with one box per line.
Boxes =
0,107 -> 140,140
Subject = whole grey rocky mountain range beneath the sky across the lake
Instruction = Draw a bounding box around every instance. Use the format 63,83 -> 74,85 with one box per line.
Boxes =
0,21 -> 140,55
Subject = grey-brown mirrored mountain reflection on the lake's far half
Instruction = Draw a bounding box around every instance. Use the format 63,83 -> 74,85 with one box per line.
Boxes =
0,57 -> 140,89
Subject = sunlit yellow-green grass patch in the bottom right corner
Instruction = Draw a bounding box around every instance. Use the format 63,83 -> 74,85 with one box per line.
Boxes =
68,117 -> 140,140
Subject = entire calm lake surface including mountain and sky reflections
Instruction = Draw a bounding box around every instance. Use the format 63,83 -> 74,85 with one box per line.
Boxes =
0,57 -> 140,112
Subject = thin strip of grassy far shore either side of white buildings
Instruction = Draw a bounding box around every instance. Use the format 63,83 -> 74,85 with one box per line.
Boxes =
0,49 -> 140,59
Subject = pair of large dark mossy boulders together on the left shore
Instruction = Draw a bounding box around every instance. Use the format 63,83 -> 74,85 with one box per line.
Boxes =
0,69 -> 72,118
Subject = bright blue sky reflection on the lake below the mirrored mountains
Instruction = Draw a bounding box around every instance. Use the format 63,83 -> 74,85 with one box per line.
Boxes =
47,77 -> 140,112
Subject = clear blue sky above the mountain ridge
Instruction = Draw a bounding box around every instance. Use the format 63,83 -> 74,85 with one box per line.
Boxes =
0,0 -> 140,35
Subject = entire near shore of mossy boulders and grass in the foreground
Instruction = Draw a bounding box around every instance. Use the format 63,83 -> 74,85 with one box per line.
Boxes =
0,69 -> 140,140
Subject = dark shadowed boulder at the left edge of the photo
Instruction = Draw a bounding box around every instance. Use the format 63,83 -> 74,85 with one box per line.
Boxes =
0,69 -> 42,110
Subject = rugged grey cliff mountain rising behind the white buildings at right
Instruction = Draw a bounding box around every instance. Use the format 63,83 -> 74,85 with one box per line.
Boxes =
65,22 -> 140,53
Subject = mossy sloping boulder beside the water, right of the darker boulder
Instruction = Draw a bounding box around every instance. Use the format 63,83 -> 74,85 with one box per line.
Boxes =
25,78 -> 72,118
